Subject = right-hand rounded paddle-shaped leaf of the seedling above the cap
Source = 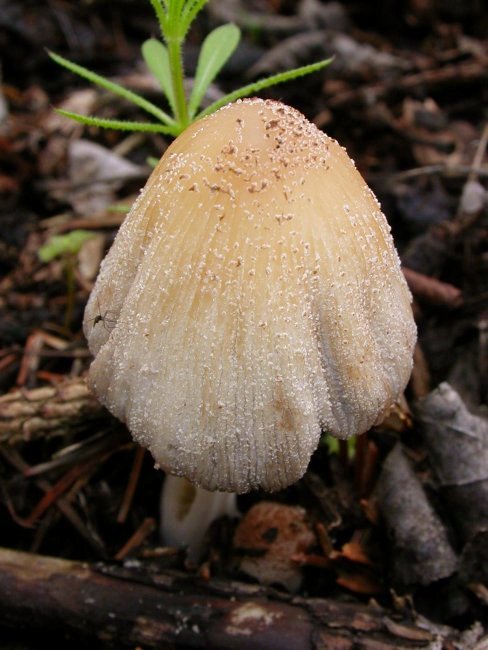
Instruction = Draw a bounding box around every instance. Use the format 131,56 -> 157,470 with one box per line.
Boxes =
188,23 -> 241,118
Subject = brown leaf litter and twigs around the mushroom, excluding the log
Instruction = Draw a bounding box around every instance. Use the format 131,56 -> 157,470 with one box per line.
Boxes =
0,1 -> 488,648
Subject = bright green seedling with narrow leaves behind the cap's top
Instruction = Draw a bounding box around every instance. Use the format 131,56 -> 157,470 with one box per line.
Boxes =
49,0 -> 332,137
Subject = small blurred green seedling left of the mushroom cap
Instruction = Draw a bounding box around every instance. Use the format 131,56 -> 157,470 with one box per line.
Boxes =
38,230 -> 95,331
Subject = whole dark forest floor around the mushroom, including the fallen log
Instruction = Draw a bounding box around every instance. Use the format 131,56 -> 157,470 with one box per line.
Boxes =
0,0 -> 488,650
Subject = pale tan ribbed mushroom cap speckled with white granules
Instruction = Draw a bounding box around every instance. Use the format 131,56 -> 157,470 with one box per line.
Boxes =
84,100 -> 416,493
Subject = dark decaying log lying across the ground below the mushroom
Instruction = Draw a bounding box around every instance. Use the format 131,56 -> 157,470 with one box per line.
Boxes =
0,549 -> 468,650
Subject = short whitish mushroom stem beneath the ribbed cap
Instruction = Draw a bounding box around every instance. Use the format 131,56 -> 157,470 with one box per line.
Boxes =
160,474 -> 240,562
